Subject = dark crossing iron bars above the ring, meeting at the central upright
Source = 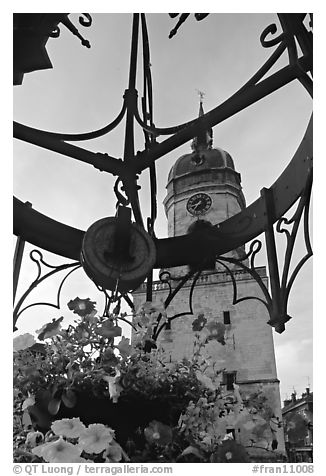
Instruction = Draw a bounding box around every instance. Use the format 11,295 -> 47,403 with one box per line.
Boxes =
14,14 -> 312,268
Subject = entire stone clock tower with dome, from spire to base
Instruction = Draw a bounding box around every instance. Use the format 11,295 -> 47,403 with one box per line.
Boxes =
133,102 -> 284,453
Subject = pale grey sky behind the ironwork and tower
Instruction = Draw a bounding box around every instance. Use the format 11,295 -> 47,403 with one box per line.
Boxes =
13,13 -> 313,399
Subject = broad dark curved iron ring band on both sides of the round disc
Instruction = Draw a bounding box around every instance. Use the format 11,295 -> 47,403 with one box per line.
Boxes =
14,118 -> 312,268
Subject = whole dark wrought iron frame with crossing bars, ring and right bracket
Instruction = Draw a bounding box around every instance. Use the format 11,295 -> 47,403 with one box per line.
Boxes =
14,13 -> 312,332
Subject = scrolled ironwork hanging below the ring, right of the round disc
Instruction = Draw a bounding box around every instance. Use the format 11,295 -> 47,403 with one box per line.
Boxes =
148,164 -> 313,340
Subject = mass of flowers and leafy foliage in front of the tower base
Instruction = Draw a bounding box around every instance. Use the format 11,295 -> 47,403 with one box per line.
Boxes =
14,298 -> 277,462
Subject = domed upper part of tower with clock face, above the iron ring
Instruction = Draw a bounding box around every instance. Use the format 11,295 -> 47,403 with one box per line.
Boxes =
163,102 -> 245,268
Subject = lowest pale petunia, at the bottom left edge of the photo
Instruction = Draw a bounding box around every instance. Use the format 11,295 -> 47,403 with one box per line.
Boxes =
32,436 -> 82,463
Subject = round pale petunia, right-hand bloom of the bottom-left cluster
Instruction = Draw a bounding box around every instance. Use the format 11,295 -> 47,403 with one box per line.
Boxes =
78,423 -> 114,454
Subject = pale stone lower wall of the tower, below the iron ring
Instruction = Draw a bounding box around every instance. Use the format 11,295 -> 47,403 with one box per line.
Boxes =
134,267 -> 285,452
